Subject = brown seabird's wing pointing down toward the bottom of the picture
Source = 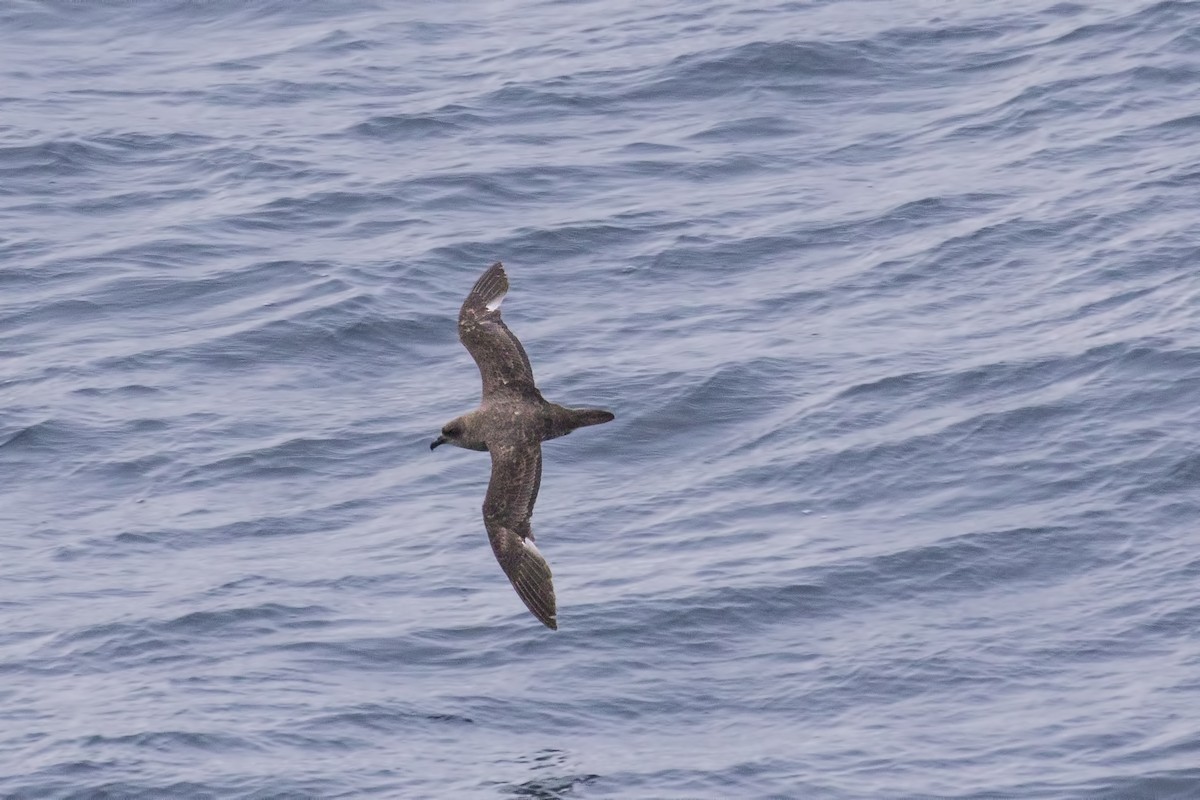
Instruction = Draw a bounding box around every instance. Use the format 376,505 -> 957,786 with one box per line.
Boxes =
484,440 -> 558,630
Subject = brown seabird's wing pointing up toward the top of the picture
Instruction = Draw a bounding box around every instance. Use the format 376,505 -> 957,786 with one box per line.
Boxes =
458,261 -> 540,399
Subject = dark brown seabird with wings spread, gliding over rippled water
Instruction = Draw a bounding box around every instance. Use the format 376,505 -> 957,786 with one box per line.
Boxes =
430,261 -> 613,630
